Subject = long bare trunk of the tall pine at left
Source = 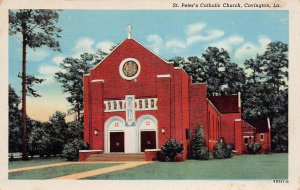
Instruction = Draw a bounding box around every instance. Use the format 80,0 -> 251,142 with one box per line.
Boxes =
22,33 -> 28,160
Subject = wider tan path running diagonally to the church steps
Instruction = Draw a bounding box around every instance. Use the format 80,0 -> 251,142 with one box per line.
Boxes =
53,161 -> 152,179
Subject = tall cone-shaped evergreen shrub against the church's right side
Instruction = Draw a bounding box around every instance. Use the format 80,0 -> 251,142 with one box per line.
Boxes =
192,124 -> 209,160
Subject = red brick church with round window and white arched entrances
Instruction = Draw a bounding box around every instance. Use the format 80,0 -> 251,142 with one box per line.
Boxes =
81,27 -> 271,159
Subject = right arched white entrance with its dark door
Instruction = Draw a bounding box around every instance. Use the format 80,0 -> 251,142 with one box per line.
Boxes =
137,115 -> 158,152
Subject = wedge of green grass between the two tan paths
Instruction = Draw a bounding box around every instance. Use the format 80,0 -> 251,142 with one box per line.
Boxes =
8,164 -> 118,179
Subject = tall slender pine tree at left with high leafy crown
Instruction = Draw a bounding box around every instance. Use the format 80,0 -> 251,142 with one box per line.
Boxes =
9,9 -> 61,160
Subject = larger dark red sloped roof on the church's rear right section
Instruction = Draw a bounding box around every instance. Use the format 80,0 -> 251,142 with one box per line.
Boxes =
208,95 -> 239,114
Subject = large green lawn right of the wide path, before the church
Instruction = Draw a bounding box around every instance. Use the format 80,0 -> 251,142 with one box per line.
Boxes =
86,154 -> 288,180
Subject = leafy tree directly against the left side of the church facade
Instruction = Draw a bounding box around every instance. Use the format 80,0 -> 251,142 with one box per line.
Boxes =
55,51 -> 107,121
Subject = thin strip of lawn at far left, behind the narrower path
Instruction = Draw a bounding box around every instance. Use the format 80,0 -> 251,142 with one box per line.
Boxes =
8,158 -> 66,169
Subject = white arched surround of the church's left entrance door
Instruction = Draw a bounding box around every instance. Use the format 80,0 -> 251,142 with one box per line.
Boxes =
104,116 -> 126,153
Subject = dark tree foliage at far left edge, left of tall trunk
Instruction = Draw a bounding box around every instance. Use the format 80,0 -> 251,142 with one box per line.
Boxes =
8,85 -> 22,157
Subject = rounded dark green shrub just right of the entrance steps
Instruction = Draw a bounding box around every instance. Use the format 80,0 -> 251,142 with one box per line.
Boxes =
161,139 -> 184,161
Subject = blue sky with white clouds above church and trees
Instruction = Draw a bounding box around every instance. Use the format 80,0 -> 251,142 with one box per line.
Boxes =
9,10 -> 289,120
